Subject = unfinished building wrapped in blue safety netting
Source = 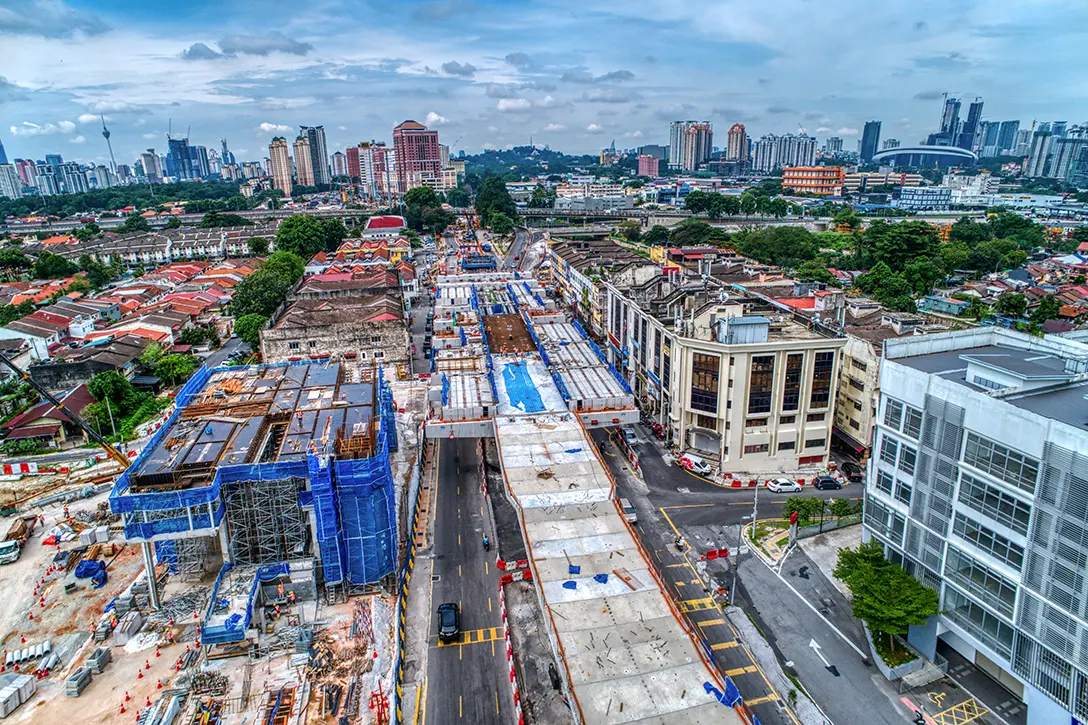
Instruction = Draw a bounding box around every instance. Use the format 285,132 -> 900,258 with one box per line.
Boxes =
110,361 -> 397,643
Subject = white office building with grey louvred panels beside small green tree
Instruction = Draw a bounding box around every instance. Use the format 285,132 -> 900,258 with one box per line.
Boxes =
864,328 -> 1088,725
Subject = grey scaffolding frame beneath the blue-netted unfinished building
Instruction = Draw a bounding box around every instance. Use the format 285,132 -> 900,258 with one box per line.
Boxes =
225,477 -> 309,566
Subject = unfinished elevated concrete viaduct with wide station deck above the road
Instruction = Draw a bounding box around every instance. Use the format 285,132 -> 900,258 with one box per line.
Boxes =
425,272 -> 751,725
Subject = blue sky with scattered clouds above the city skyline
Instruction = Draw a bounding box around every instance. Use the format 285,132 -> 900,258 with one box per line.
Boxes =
0,0 -> 1088,163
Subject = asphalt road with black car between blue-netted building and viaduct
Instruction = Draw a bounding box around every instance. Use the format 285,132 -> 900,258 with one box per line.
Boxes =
423,439 -> 514,725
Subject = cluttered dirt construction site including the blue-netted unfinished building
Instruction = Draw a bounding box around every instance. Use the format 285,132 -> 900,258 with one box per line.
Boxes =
0,360 -> 415,725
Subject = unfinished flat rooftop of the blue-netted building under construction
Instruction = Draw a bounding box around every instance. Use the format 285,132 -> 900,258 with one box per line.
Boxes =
125,364 -> 376,493
